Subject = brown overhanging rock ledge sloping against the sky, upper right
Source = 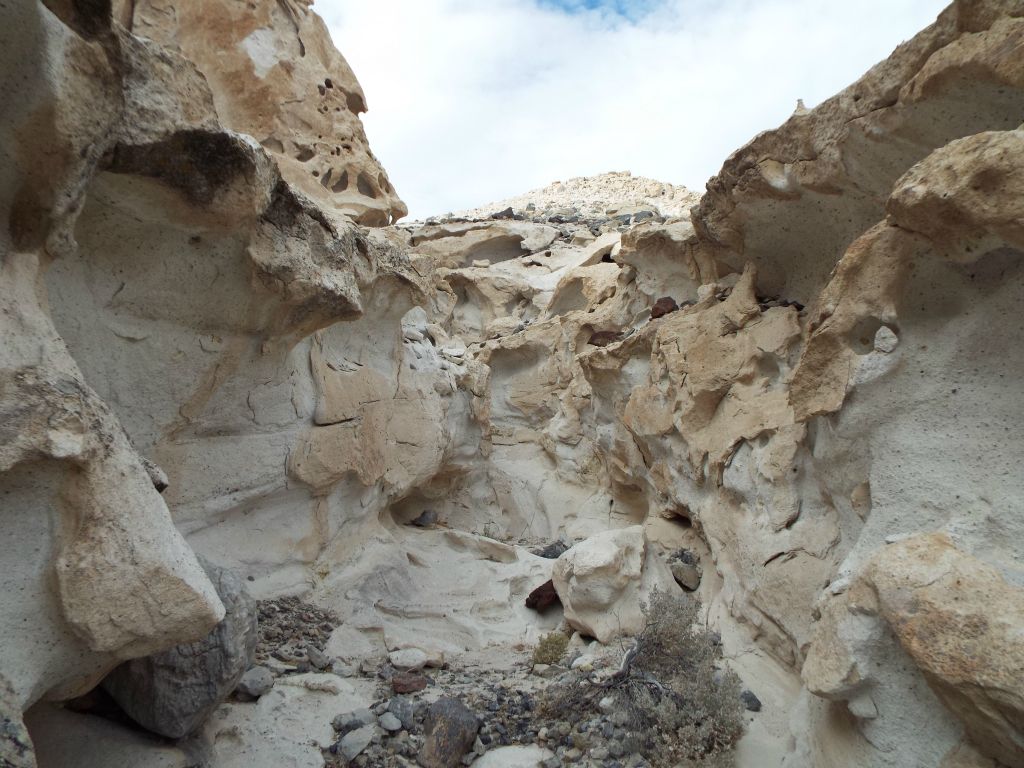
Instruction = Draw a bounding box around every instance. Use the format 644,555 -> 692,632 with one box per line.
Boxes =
694,0 -> 1024,303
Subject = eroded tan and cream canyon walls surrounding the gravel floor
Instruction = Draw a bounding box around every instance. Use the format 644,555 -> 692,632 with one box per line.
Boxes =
0,0 -> 1024,768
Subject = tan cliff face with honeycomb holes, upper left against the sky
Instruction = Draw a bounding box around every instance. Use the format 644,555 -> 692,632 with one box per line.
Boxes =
132,0 -> 408,226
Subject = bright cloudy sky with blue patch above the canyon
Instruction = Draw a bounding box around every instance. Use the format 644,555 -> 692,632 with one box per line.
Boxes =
314,0 -> 946,218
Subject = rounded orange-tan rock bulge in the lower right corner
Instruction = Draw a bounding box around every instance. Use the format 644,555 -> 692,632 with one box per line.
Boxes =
804,534 -> 1024,765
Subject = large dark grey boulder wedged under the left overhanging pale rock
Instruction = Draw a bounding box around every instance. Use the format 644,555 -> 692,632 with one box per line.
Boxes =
103,560 -> 257,738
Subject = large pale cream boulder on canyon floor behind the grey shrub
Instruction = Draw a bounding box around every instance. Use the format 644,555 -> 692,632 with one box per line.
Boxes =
552,525 -> 679,643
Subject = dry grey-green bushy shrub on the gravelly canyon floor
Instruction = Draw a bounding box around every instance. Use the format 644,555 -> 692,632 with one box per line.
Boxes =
542,591 -> 742,766
